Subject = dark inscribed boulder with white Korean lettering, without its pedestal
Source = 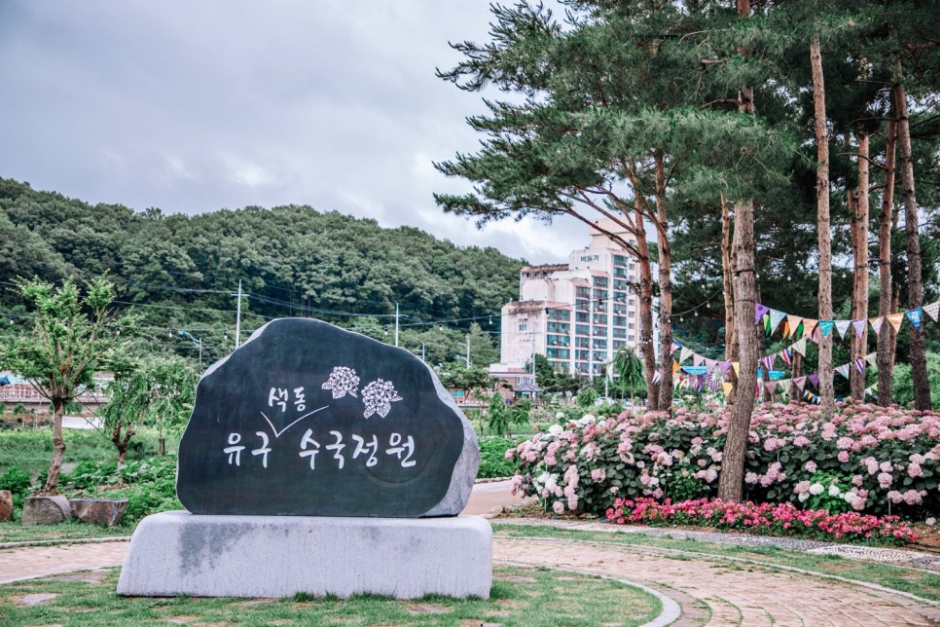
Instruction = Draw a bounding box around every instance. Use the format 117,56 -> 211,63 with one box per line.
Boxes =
177,318 -> 476,517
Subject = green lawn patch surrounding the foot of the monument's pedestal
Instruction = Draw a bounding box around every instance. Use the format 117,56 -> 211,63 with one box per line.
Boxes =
0,567 -> 661,627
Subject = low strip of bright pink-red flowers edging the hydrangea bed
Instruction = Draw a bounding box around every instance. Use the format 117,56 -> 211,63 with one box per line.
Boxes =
607,498 -> 916,544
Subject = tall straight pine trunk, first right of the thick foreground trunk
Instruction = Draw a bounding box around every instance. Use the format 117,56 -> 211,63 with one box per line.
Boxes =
810,36 -> 835,416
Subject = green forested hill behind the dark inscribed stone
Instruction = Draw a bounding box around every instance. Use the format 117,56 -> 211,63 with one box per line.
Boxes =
0,178 -> 523,363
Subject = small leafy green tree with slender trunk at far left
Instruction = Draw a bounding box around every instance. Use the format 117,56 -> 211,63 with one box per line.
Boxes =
0,278 -> 126,494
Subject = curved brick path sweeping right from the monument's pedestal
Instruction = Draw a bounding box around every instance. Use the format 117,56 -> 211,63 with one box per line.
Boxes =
494,538 -> 940,627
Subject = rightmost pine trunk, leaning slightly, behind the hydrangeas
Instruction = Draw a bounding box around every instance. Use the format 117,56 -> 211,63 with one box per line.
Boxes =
894,68 -> 932,411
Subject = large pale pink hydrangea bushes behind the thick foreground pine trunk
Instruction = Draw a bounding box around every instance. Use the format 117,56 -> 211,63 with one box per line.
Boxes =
506,402 -> 940,519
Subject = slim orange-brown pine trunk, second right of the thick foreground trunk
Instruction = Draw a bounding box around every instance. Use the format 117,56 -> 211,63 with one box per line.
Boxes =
849,131 -> 869,401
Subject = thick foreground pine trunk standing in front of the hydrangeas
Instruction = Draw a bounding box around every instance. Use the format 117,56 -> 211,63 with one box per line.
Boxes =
718,0 -> 757,502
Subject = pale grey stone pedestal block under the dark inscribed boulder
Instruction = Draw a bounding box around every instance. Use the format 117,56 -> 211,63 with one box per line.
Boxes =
117,512 -> 493,599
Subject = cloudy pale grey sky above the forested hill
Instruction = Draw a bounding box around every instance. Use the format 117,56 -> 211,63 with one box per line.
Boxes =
0,0 -> 588,263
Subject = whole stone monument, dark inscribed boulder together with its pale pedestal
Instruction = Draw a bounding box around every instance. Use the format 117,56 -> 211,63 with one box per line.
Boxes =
118,318 -> 492,598
